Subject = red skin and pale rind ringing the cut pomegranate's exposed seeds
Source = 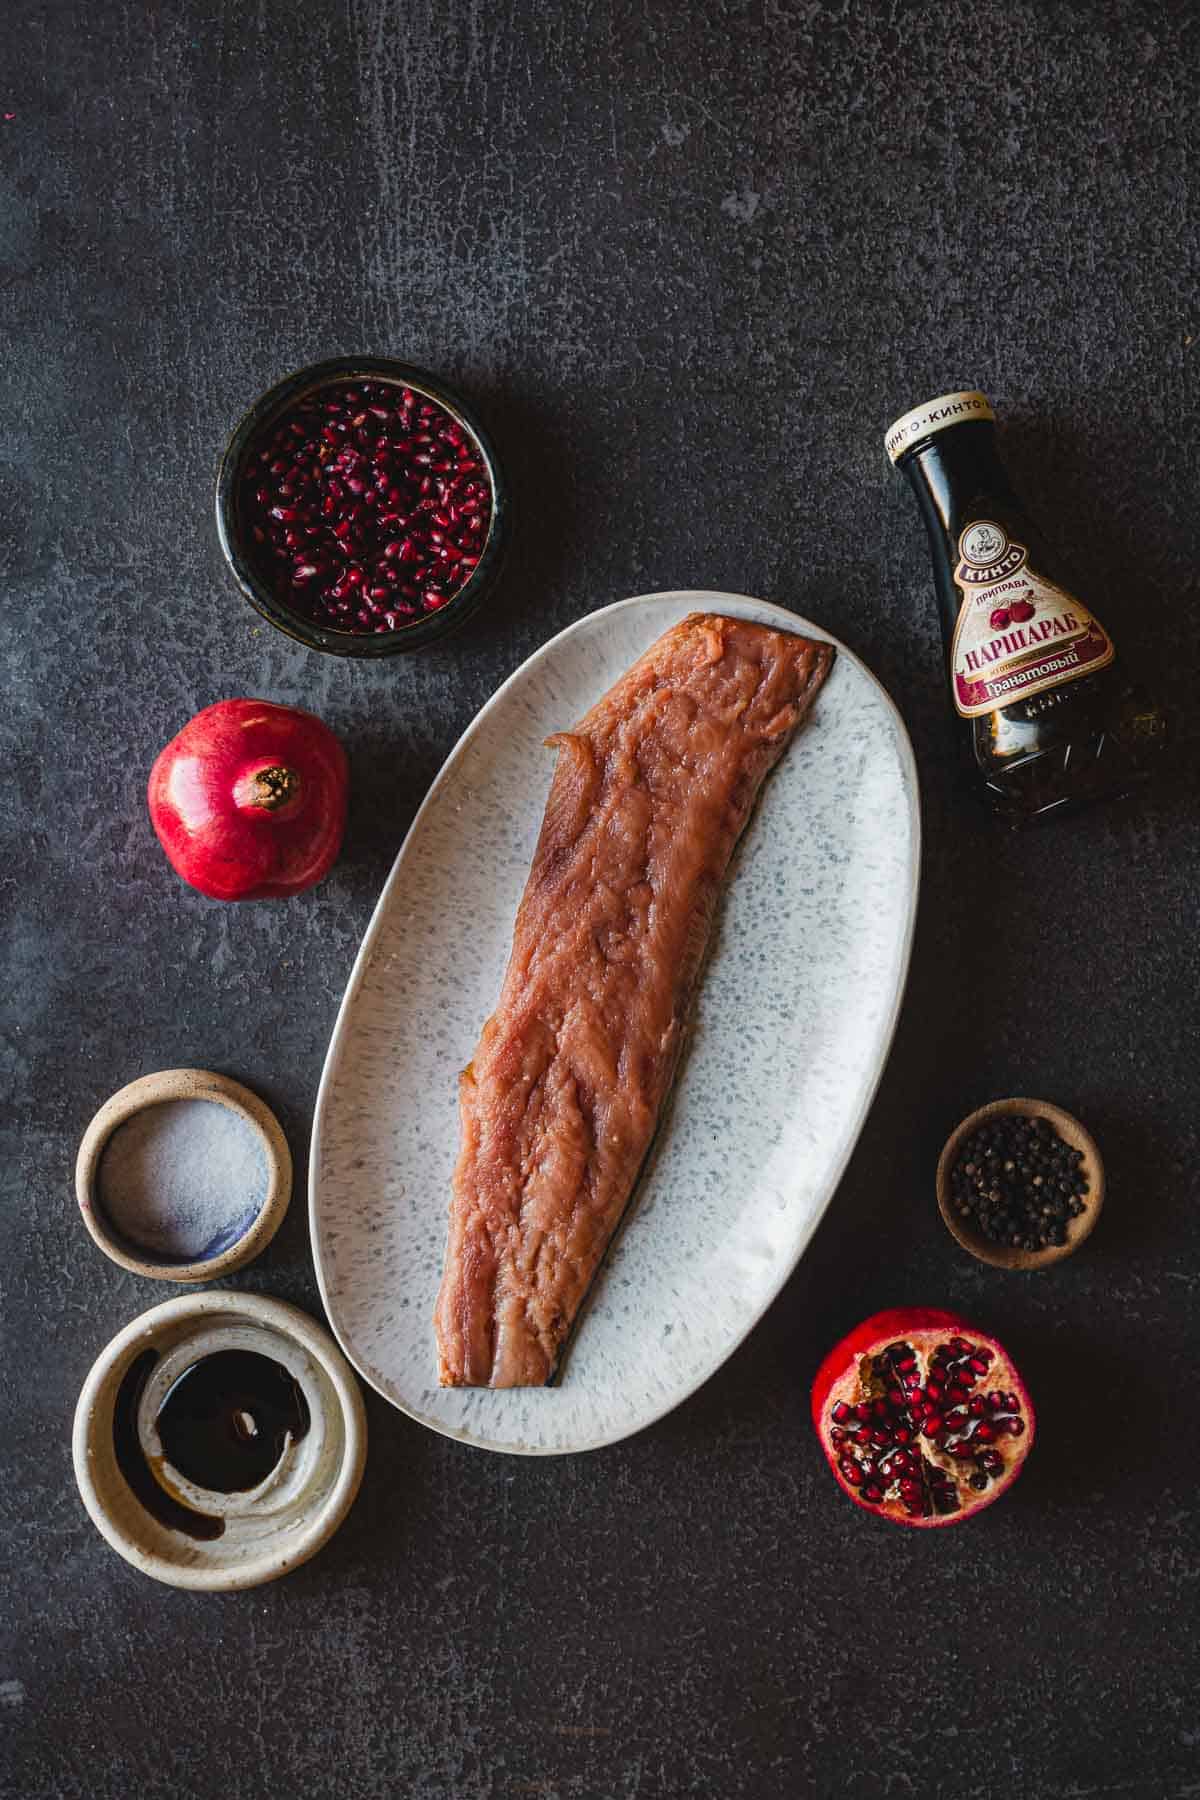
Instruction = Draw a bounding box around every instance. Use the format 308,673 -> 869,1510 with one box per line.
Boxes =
811,1307 -> 1036,1530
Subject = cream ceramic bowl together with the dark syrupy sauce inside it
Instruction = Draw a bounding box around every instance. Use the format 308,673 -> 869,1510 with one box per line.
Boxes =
72,1292 -> 367,1589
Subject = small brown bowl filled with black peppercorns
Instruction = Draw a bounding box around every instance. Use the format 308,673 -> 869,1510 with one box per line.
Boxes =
937,1100 -> 1105,1269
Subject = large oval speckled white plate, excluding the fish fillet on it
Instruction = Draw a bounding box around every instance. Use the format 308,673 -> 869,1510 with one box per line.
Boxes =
311,592 -> 919,1454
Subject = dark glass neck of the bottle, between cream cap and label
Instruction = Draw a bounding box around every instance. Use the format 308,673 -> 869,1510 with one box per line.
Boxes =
900,419 -> 1034,643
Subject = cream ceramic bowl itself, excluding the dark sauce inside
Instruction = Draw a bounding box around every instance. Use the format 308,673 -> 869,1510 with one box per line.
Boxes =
72,1292 -> 367,1591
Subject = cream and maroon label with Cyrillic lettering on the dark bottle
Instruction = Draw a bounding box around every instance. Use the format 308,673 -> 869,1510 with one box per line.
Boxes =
950,518 -> 1115,718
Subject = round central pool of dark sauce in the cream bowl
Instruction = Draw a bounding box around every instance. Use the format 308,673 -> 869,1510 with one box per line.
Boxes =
155,1350 -> 309,1494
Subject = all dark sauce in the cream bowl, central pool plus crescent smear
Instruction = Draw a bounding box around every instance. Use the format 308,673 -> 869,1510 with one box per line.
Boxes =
113,1350 -> 309,1541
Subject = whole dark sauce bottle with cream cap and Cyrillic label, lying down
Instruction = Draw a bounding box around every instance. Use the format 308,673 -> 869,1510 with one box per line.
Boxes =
883,392 -> 1166,824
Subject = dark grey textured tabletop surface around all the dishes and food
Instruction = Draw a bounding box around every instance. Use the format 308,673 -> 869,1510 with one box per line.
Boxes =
0,0 -> 1200,1800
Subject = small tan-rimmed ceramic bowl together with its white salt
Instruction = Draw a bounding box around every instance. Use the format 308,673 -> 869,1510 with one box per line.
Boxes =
76,1069 -> 291,1282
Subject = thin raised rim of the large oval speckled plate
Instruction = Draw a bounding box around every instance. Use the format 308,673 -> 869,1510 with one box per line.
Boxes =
308,587 -> 923,1456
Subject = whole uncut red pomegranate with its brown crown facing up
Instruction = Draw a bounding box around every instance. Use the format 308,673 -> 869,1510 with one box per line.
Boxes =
146,700 -> 349,900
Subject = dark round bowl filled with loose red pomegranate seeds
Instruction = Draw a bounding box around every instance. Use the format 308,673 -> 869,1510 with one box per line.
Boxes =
216,358 -> 509,657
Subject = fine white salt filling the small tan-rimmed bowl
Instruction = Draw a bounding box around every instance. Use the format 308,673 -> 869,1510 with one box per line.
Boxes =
97,1100 -> 268,1262
